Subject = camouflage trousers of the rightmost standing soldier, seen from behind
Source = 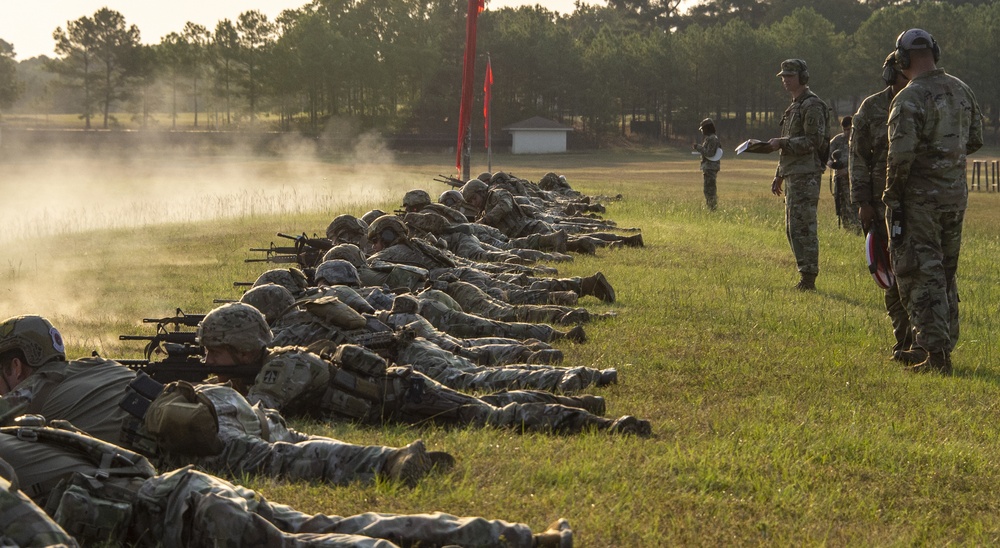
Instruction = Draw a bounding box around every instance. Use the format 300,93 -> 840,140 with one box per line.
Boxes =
889,203 -> 965,352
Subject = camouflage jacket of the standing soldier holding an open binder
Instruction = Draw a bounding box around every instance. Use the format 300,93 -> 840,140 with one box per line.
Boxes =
775,88 -> 827,177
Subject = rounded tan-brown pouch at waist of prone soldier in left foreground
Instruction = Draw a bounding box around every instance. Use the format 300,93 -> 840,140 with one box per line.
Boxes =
144,381 -> 223,457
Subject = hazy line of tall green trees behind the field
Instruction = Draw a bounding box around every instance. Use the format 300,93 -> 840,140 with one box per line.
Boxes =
0,0 -> 1000,142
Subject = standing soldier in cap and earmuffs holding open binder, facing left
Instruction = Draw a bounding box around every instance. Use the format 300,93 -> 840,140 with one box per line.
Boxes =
768,59 -> 829,291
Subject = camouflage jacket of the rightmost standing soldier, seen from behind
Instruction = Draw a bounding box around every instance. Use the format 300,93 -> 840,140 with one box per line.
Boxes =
882,69 -> 983,211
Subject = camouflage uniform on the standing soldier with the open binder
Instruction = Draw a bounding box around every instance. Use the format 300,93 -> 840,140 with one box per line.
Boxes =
775,87 -> 827,276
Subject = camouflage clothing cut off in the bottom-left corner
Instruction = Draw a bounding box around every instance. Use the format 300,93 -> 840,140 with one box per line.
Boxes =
0,477 -> 77,547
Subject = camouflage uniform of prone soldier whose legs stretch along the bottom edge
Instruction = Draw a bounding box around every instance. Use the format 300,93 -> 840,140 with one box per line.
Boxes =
0,428 -> 556,548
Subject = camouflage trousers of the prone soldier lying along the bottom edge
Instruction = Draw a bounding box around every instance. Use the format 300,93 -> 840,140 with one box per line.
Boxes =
136,468 -> 532,548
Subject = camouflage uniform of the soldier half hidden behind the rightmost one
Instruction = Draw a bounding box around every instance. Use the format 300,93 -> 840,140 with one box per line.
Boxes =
848,87 -> 913,352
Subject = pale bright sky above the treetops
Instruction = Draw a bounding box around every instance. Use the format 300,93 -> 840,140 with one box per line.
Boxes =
0,0 -> 605,61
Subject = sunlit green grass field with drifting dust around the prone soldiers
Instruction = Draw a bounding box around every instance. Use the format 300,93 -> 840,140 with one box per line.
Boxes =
0,143 -> 1000,547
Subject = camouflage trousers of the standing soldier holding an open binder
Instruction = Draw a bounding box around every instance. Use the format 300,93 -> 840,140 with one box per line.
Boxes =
785,172 -> 823,274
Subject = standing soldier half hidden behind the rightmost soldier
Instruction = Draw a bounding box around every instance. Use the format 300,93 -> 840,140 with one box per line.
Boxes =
848,52 -> 923,363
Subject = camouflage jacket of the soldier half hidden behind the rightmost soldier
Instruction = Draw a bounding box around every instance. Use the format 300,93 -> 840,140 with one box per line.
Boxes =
848,87 -> 892,206
